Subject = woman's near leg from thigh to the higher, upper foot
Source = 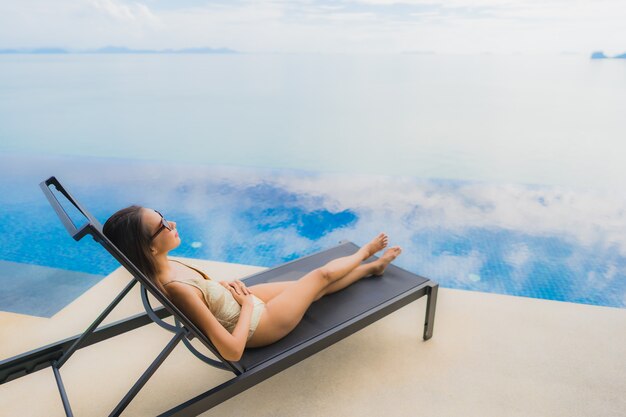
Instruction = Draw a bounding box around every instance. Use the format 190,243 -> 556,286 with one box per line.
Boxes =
255,233 -> 387,343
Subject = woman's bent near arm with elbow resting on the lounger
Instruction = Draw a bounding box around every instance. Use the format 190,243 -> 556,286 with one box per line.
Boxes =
168,283 -> 254,361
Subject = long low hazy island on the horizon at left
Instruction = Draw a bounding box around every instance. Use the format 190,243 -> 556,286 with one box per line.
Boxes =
0,46 -> 240,55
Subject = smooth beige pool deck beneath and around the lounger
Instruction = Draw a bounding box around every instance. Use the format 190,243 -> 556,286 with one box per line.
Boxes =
0,260 -> 626,417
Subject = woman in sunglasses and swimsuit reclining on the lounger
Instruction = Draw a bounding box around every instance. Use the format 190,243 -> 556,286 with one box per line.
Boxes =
103,206 -> 401,361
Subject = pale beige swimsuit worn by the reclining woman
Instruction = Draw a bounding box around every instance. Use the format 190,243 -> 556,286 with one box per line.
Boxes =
163,259 -> 265,340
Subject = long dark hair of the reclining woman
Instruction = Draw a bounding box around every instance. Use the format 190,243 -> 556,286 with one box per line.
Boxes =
102,206 -> 163,291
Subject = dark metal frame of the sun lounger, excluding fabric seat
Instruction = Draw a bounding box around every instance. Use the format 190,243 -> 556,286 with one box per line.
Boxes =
0,177 -> 439,416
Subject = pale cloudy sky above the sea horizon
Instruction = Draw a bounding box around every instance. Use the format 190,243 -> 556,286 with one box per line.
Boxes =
0,0 -> 626,55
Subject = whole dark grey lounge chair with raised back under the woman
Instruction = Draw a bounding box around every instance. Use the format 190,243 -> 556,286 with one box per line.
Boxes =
0,177 -> 438,416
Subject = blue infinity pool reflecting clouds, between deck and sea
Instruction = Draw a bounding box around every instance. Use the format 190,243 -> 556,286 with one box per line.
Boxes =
0,155 -> 626,316
